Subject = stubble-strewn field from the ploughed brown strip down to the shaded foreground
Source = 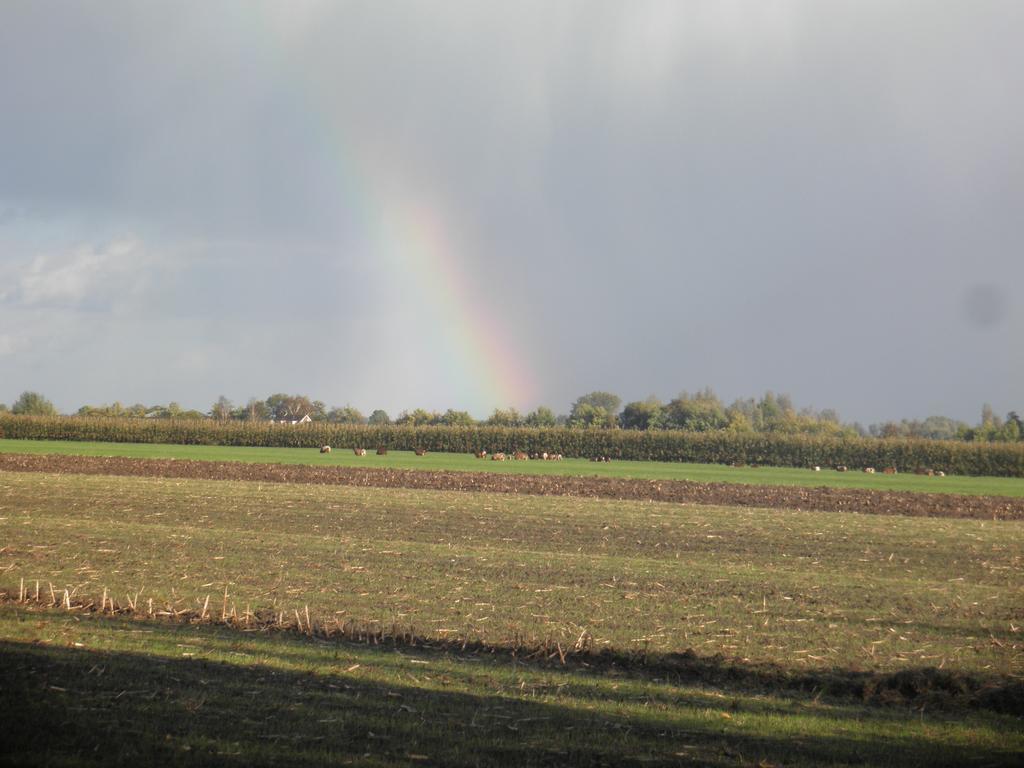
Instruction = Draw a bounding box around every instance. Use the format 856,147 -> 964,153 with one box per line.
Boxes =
0,473 -> 1024,765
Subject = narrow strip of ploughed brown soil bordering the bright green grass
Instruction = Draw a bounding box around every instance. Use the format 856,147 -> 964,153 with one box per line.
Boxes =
0,454 -> 1024,520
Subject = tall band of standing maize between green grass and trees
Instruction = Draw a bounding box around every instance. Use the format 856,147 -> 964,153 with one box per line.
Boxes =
0,415 -> 1024,477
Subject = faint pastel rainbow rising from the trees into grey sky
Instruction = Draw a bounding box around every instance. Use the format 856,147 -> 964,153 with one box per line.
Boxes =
260,12 -> 538,417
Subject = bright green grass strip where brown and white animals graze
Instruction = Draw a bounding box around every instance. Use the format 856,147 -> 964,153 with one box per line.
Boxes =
0,439 -> 1024,497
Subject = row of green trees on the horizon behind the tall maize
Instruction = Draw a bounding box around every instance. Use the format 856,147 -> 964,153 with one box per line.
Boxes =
0,388 -> 1024,442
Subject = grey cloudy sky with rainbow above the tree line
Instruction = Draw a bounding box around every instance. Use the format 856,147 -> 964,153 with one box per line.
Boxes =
0,0 -> 1024,424
